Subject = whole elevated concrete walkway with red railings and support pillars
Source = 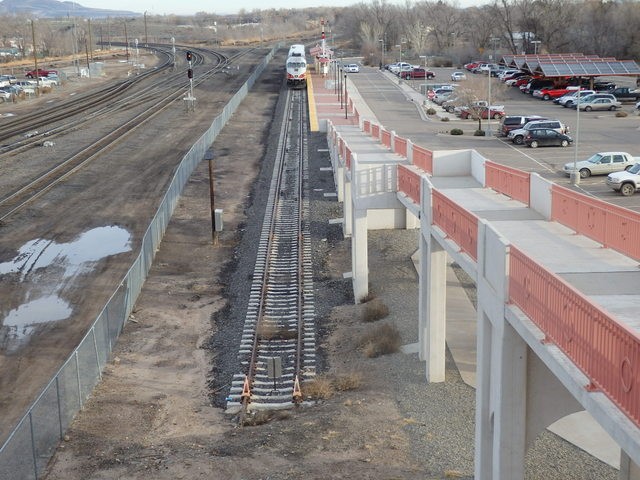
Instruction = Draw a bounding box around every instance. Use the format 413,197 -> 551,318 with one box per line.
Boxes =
304,68 -> 640,480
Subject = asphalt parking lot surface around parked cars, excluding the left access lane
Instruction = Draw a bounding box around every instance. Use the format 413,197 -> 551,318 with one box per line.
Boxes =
402,68 -> 640,212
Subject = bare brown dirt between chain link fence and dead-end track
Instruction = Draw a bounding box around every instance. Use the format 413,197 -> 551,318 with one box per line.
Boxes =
35,48 -> 442,480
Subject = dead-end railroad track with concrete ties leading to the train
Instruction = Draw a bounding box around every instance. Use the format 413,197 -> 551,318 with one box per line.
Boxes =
227,90 -> 316,415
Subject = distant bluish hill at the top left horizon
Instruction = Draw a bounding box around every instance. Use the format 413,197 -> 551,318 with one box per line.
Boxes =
0,0 -> 142,18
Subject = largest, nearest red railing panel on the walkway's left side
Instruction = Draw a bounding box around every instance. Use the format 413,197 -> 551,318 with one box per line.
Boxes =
509,245 -> 640,426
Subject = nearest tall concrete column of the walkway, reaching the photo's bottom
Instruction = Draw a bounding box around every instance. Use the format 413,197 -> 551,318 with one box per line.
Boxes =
475,222 -> 527,480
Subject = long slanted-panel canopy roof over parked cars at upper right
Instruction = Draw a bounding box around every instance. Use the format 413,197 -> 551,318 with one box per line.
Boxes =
500,53 -> 640,78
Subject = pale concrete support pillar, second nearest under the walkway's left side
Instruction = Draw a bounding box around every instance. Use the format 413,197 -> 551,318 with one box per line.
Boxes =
419,235 -> 447,382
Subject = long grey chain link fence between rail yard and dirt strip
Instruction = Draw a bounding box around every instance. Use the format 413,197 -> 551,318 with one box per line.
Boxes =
0,46 -> 279,480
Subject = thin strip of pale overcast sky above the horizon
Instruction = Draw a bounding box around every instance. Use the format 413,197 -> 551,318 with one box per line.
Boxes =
76,0 -> 477,15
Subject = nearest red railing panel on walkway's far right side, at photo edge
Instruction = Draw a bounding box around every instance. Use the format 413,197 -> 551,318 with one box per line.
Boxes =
551,185 -> 640,260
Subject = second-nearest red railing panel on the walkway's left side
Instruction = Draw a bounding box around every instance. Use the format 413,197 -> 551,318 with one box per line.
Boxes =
431,188 -> 478,260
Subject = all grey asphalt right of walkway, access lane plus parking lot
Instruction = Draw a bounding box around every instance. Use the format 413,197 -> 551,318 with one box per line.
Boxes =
350,63 -> 640,212
